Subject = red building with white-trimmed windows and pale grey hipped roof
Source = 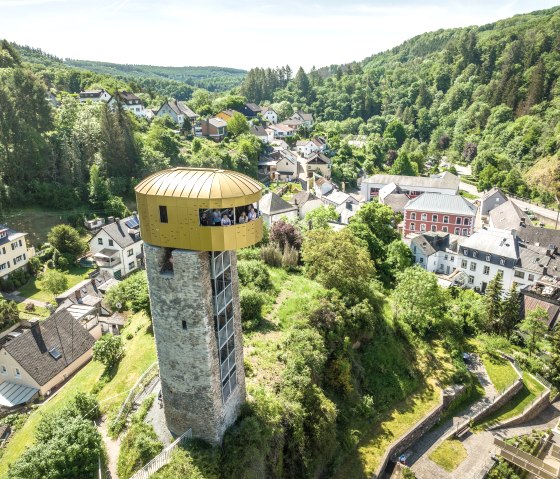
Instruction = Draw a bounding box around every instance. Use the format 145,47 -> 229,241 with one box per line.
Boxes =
403,193 -> 477,236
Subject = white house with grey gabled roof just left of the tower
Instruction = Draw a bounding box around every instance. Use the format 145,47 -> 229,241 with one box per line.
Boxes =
89,214 -> 144,279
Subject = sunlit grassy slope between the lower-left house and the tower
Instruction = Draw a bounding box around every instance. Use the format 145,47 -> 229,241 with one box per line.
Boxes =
0,313 -> 156,478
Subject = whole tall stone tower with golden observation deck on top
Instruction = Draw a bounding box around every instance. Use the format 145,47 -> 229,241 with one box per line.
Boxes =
136,168 -> 262,444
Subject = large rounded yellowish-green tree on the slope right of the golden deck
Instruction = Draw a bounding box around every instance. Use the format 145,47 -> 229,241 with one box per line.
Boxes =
302,229 -> 375,299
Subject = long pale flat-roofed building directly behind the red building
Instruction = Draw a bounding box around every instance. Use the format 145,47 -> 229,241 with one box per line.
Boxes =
360,171 -> 459,201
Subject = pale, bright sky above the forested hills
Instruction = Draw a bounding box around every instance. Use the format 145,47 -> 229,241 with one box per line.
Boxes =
0,0 -> 559,70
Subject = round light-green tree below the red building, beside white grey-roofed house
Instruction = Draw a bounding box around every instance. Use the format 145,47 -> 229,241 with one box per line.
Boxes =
393,266 -> 448,338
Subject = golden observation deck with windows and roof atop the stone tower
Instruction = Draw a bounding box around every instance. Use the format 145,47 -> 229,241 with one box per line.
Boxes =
135,167 -> 263,251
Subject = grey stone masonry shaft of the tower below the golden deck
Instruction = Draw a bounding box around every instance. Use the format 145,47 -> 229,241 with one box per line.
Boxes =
144,243 -> 245,444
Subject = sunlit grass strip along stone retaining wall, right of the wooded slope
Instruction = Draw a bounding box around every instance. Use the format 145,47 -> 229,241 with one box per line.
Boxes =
333,384 -> 441,479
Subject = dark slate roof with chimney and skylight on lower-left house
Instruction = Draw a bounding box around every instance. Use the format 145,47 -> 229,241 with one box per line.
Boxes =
4,311 -> 95,386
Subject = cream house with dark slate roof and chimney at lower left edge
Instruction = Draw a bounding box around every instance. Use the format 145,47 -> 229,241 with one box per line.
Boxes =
0,310 -> 95,408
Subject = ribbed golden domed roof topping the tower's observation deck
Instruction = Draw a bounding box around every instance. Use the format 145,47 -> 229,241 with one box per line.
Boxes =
135,167 -> 262,200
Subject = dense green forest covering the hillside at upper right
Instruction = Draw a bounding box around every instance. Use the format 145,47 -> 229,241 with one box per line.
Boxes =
241,7 -> 560,201
